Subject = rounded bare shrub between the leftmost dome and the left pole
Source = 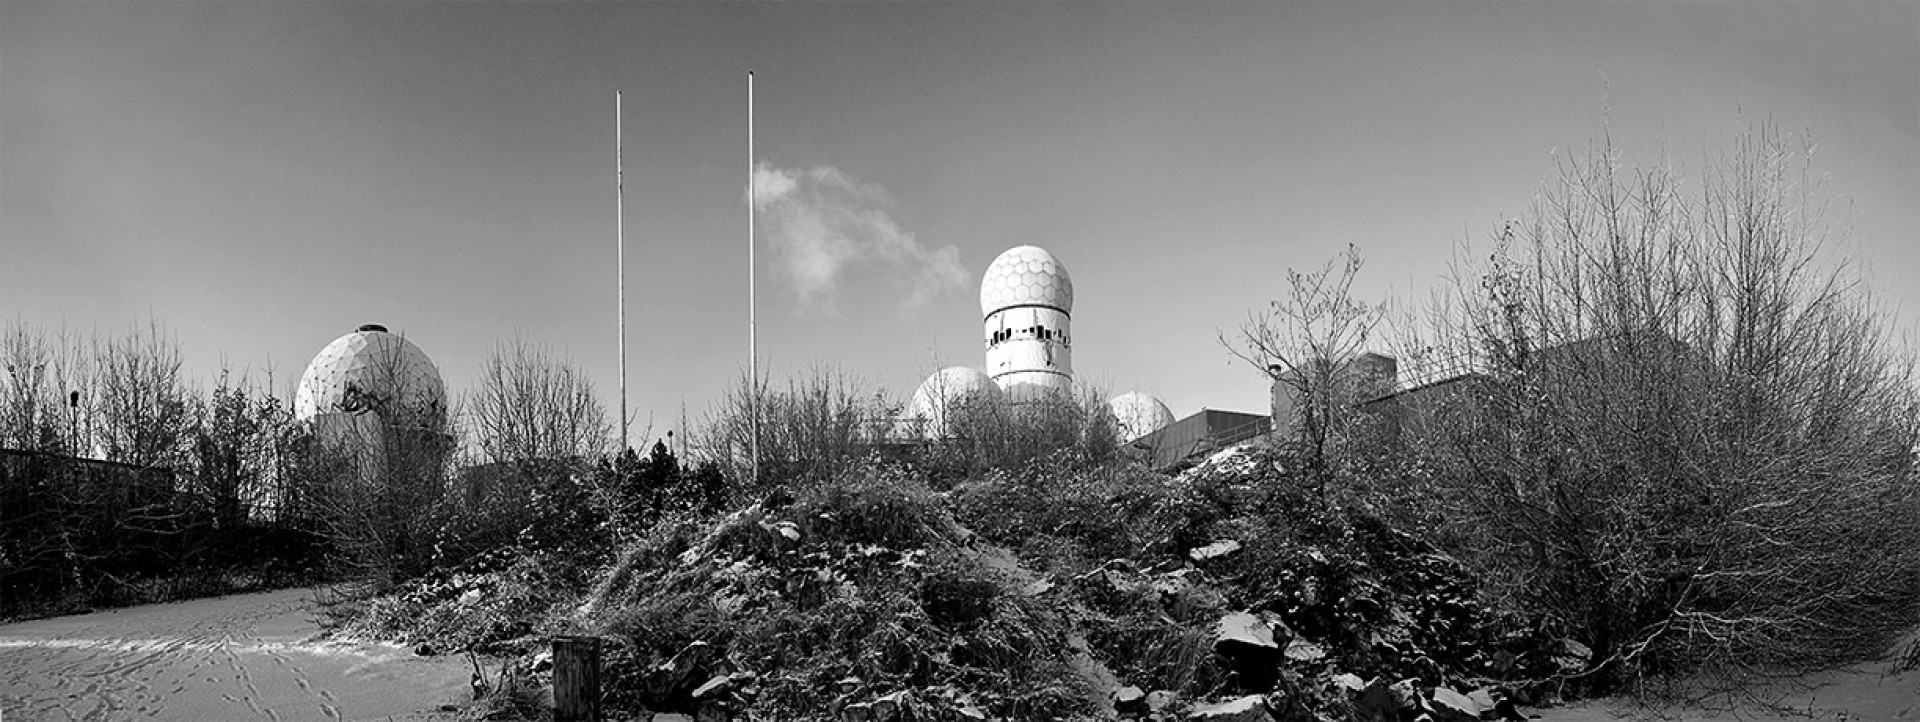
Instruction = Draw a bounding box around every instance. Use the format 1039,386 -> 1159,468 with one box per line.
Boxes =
465,340 -> 612,463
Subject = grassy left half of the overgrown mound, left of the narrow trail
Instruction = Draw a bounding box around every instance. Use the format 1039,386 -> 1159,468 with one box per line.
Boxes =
584,467 -> 1094,718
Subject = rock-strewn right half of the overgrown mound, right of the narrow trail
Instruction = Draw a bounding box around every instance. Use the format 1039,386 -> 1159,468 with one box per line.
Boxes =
954,447 -> 1584,716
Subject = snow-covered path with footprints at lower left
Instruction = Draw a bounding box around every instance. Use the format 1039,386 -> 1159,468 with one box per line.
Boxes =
0,590 -> 470,722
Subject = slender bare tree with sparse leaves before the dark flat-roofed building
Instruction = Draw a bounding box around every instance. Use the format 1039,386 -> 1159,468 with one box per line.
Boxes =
1219,244 -> 1386,470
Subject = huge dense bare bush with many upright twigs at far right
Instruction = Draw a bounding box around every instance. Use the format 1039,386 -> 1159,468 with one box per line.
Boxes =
1409,127 -> 1920,686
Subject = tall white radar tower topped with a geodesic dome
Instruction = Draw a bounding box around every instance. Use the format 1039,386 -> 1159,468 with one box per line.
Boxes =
979,246 -> 1073,401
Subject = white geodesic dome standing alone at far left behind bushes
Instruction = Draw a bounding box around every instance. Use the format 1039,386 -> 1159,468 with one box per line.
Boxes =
294,330 -> 447,428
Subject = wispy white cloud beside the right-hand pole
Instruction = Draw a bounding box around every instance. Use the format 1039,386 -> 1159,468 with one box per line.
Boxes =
753,163 -> 970,313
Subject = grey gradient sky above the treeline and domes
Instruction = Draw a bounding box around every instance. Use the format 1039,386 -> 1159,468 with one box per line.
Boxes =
0,0 -> 1920,451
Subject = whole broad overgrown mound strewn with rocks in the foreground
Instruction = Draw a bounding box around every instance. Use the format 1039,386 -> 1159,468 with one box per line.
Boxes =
345,449 -> 1584,720
